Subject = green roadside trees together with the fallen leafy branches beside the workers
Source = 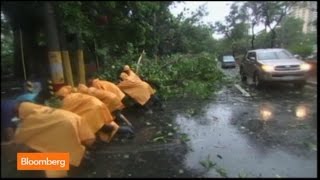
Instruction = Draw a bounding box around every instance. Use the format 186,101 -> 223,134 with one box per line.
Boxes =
1,1 -> 317,99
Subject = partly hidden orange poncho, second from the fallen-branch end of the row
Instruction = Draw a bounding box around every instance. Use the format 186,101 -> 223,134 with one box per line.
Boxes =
92,79 -> 126,100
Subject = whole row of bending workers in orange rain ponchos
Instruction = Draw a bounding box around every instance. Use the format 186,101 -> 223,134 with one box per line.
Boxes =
5,65 -> 162,177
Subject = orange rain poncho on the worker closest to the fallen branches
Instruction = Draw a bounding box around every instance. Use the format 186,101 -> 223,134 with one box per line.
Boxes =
118,72 -> 155,105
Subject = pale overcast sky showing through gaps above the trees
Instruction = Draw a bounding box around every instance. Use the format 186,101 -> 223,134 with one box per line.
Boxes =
170,1 -> 264,39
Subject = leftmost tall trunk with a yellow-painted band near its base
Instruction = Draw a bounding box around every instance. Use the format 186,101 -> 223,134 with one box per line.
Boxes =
44,2 -> 65,90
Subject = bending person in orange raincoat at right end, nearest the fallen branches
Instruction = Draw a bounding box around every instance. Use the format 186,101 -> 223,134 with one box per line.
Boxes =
118,65 -> 163,112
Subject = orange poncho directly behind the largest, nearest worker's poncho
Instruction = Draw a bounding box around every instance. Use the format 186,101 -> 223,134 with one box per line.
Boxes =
57,86 -> 119,142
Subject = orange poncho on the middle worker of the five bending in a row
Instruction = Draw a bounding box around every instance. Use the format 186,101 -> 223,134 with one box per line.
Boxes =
78,84 -> 124,112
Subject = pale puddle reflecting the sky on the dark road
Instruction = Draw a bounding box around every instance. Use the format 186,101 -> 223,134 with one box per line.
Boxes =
176,104 -> 317,177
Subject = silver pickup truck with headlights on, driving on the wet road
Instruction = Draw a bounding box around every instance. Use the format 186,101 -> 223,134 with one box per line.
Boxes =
240,49 -> 310,87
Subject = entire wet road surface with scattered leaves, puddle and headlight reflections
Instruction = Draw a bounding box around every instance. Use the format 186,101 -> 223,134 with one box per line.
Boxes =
1,65 -> 317,177
